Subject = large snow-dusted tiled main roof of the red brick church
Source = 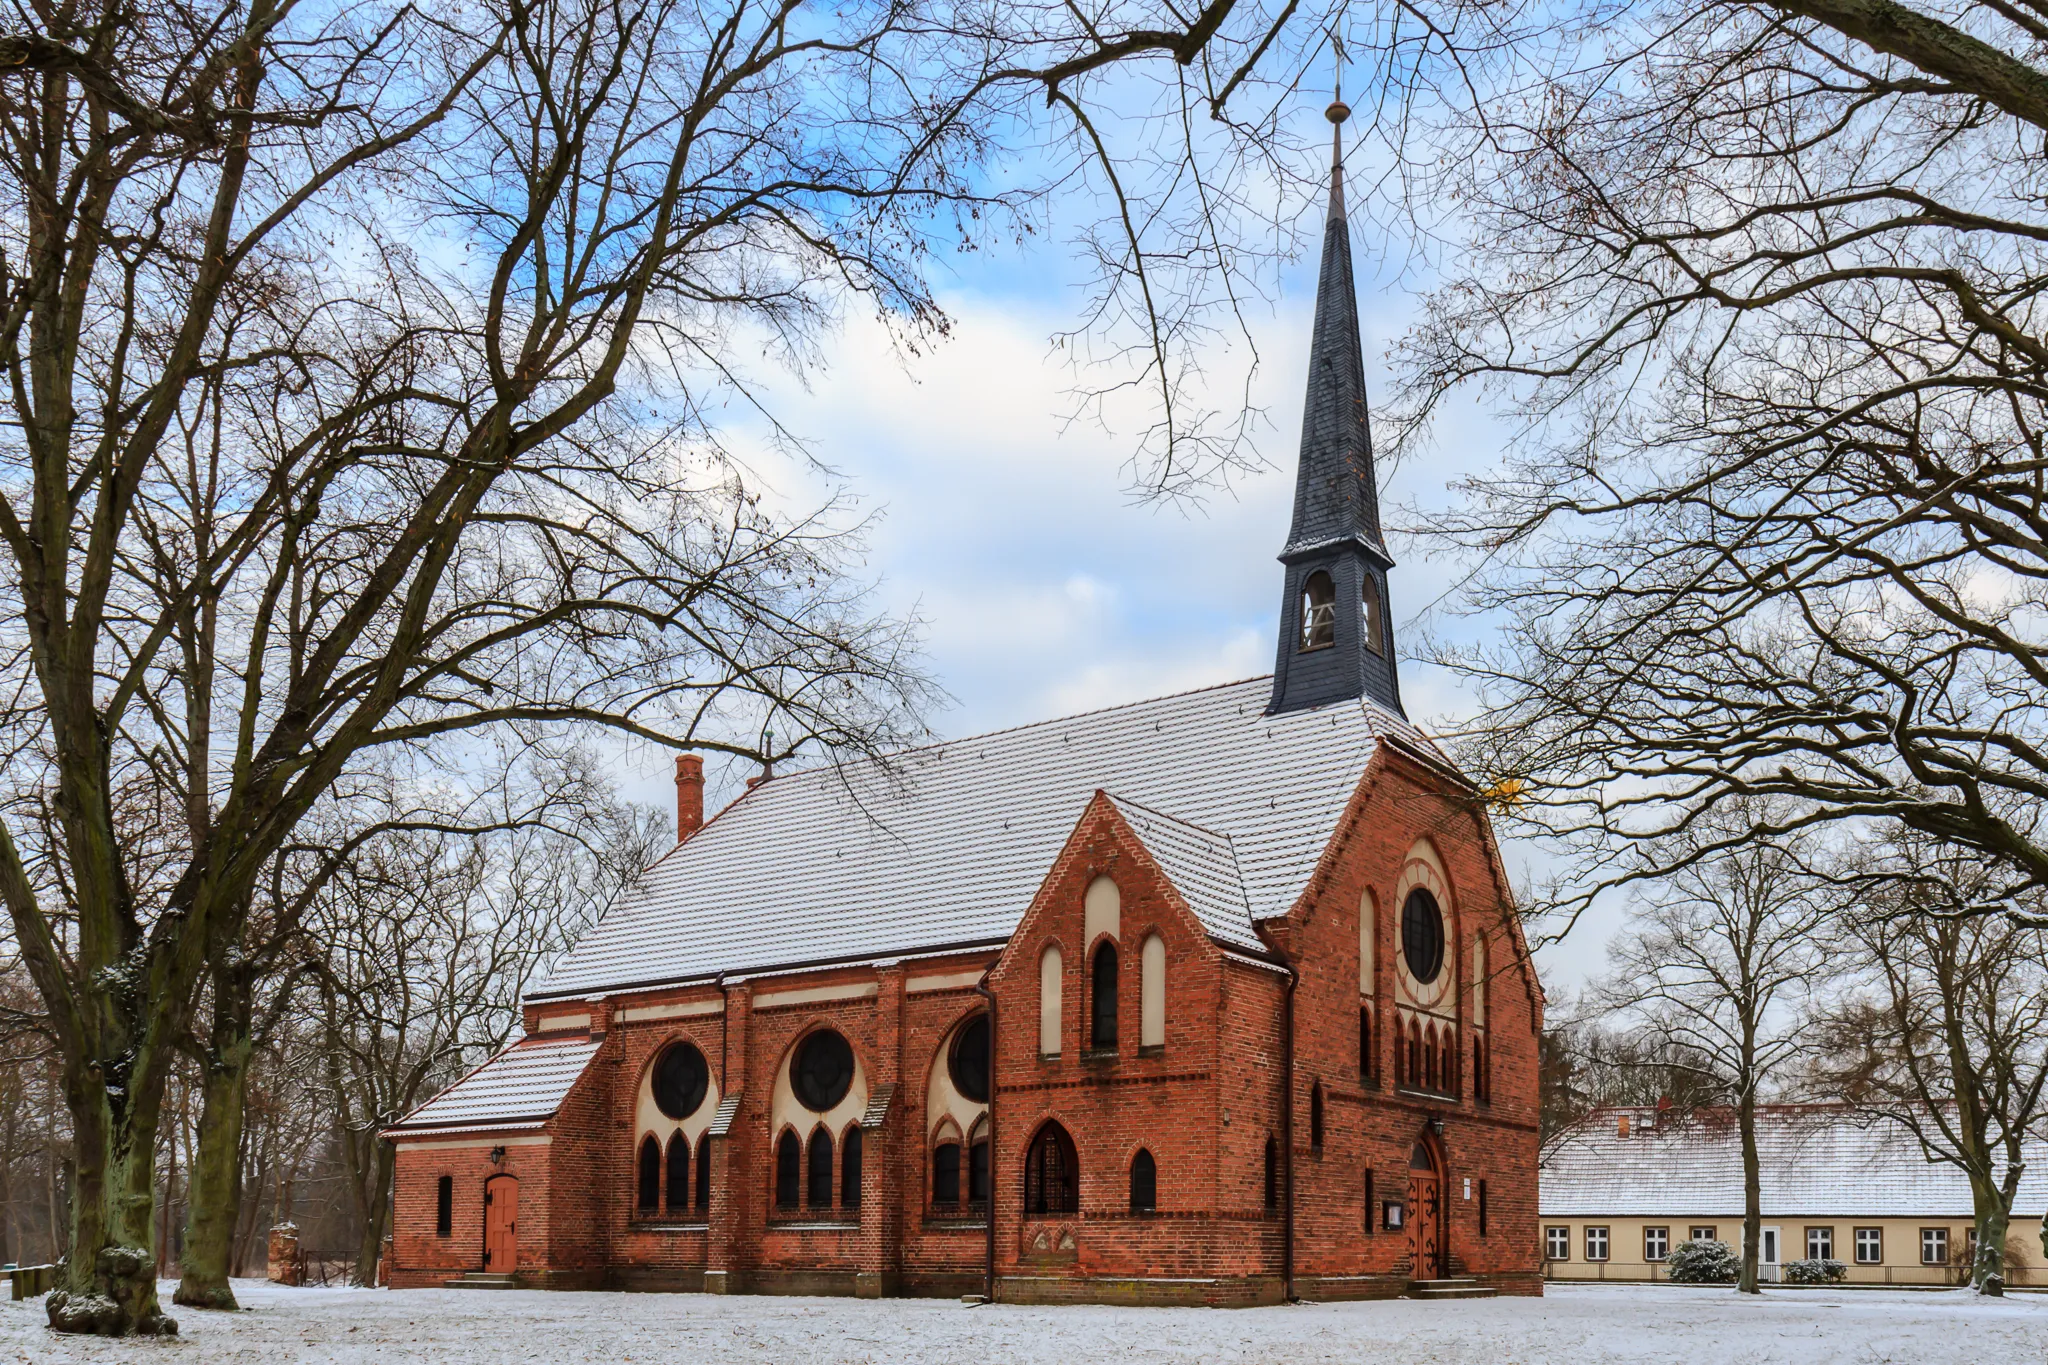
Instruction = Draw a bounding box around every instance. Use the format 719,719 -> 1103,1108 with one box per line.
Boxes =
530,677 -> 1442,999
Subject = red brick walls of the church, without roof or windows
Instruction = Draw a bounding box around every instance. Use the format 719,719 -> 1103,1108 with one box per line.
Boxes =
393,747 -> 1542,1304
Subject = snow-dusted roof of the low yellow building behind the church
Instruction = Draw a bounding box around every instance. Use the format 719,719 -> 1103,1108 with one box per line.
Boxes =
1538,1105 -> 2048,1218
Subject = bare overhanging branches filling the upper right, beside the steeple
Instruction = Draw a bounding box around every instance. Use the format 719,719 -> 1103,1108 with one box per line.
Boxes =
1356,0 -> 2048,929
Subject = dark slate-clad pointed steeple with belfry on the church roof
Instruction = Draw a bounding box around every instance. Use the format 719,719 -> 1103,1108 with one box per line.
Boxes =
1266,94 -> 1405,714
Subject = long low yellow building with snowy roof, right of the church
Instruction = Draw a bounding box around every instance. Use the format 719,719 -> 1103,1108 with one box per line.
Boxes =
1538,1105 -> 2048,1287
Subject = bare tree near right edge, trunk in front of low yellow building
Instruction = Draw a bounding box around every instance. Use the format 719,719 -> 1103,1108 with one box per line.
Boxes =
1815,843 -> 2048,1293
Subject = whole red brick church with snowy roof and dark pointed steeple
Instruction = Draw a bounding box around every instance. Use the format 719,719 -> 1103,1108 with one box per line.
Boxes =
385,106 -> 1542,1304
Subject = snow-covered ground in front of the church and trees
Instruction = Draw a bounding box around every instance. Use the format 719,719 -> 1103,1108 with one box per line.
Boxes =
0,1281 -> 2048,1365
